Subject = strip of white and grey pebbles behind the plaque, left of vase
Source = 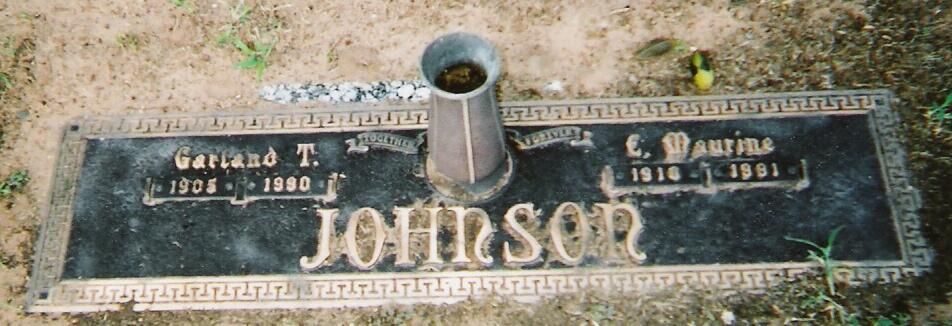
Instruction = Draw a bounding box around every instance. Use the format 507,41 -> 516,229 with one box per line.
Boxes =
259,80 -> 430,104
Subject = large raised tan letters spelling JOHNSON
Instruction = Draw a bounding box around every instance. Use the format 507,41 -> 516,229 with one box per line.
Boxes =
290,201 -> 647,272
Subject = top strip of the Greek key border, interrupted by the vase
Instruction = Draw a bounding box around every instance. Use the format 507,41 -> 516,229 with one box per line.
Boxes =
77,90 -> 889,137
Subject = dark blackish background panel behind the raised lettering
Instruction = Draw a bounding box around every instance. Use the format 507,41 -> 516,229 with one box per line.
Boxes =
62,115 -> 902,279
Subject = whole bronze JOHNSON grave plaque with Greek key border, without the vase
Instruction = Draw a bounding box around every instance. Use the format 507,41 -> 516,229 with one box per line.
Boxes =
27,90 -> 932,312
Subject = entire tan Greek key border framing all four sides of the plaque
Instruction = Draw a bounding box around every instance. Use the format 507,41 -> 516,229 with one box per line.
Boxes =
26,90 -> 933,312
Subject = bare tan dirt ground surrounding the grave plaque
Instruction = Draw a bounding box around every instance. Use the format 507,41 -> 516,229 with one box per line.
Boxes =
0,0 -> 952,325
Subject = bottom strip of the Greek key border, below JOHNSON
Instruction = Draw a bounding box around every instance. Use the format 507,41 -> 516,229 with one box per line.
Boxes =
29,262 -> 914,312
